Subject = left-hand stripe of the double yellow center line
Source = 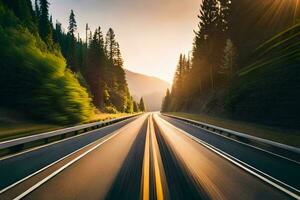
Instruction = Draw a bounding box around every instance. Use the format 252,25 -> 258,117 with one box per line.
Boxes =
142,118 -> 150,200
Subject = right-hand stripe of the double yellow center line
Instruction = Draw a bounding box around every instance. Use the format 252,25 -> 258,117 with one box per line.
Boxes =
149,115 -> 164,200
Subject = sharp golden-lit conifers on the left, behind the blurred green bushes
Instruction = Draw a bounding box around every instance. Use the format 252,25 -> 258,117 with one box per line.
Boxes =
54,20 -> 132,112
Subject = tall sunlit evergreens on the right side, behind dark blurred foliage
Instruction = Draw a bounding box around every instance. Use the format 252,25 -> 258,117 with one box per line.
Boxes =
162,0 -> 300,128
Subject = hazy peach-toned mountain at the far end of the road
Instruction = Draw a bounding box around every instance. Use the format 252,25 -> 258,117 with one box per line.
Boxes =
125,70 -> 171,111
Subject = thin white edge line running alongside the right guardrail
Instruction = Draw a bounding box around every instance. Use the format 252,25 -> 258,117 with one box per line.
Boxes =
162,115 -> 300,165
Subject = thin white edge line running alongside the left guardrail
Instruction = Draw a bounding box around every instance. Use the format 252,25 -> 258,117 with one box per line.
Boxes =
0,117 -> 134,161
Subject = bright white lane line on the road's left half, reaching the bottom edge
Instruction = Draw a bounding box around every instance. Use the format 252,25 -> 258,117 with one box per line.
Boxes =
14,127 -> 121,200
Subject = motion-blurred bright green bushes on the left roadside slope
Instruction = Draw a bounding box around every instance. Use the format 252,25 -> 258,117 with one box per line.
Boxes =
0,5 -> 92,123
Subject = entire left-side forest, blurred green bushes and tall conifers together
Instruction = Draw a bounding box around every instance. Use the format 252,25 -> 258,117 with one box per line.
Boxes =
0,0 -> 145,123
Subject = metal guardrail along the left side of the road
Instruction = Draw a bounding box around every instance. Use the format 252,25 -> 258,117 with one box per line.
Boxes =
0,114 -> 139,156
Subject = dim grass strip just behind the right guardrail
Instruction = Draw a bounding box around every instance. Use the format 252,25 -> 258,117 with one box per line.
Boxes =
166,112 -> 300,148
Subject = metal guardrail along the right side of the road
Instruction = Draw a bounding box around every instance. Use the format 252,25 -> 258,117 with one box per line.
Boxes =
161,113 -> 300,162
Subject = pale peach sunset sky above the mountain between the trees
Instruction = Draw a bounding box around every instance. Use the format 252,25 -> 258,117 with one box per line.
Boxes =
50,0 -> 201,83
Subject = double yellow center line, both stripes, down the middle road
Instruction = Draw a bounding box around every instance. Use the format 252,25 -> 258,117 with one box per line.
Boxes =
142,114 -> 166,200
